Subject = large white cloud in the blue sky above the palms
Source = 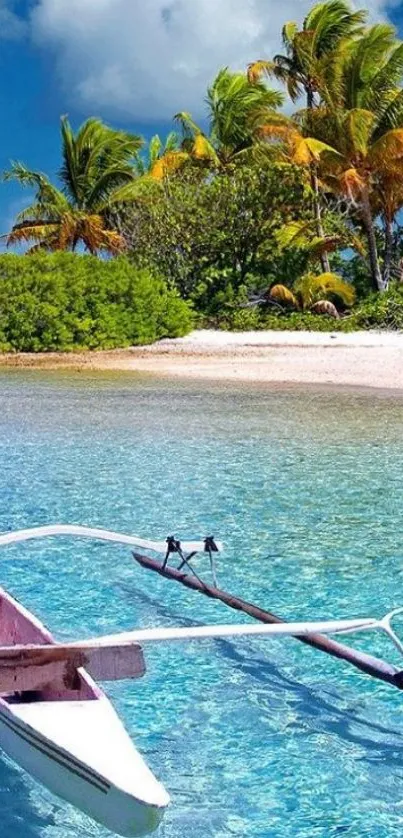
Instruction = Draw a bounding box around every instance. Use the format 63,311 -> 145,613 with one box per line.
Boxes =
30,0 -> 399,121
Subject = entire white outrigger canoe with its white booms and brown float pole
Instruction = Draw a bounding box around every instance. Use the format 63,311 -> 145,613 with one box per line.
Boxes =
0,525 -> 403,838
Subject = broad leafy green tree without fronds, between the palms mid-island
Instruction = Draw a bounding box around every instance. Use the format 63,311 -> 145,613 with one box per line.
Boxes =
115,164 -> 310,314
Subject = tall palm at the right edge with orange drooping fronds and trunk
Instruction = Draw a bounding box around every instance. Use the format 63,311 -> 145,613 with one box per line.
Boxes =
305,24 -> 403,291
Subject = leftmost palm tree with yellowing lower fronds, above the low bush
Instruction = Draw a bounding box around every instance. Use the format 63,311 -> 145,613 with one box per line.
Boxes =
4,117 -> 142,254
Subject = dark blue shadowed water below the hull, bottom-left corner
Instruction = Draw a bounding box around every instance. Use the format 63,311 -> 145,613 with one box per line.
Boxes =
0,751 -> 55,838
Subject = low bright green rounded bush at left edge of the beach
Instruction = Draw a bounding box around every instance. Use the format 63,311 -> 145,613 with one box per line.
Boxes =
0,253 -> 192,352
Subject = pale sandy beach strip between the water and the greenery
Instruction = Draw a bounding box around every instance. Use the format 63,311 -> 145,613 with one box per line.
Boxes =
0,331 -> 403,390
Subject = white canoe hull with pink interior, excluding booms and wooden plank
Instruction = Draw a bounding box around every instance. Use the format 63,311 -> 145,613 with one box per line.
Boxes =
0,590 -> 169,836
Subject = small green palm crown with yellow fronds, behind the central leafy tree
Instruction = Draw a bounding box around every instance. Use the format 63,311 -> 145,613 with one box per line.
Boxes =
175,68 -> 283,168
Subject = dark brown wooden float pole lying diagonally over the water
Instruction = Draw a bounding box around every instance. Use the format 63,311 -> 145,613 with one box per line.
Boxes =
133,553 -> 403,690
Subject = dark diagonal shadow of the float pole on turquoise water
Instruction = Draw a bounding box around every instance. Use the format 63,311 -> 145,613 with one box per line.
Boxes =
119,584 -> 403,768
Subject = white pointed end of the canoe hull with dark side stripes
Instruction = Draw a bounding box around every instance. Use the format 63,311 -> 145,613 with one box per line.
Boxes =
0,696 -> 169,838
